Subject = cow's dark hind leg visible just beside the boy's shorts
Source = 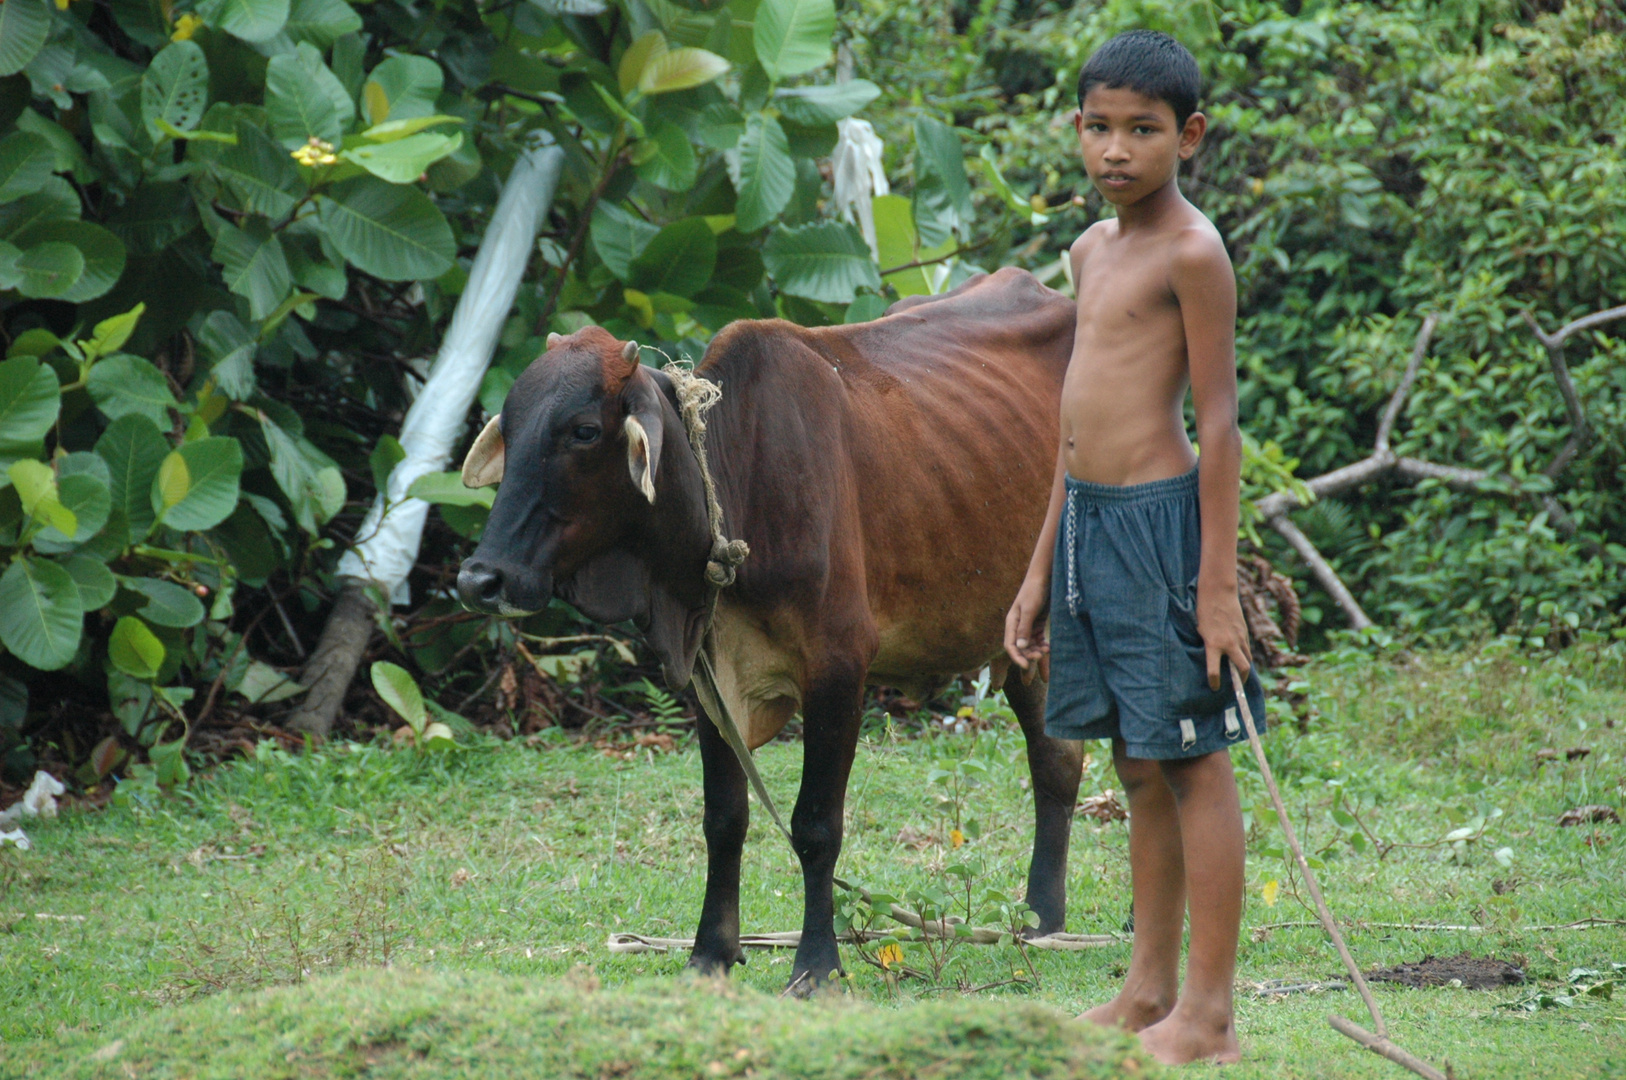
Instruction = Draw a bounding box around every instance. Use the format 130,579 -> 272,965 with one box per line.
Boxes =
1005,665 -> 1085,934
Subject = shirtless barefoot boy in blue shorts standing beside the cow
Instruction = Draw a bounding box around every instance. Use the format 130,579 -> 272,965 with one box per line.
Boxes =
1005,31 -> 1265,1064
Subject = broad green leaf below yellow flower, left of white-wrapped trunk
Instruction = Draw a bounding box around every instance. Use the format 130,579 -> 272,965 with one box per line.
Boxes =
320,176 -> 457,281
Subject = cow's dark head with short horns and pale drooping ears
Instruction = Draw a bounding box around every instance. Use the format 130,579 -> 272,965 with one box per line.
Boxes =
457,327 -> 709,685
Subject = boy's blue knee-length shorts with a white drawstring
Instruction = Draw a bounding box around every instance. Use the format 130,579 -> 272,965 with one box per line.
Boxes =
1044,468 -> 1265,760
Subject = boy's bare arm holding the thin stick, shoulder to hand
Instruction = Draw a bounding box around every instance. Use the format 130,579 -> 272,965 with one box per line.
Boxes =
1171,229 -> 1254,690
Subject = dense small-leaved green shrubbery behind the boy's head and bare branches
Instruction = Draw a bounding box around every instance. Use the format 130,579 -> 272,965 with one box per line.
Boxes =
850,0 -> 1626,636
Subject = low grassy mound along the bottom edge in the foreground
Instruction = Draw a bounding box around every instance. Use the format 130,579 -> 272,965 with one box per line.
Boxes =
12,969 -> 1159,1080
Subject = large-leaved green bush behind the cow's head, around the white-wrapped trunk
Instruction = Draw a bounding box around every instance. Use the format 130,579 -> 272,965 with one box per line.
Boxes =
0,0 -> 1014,784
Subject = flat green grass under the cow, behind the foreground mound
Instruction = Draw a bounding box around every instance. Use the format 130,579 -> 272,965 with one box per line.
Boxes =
0,649 -> 1626,1080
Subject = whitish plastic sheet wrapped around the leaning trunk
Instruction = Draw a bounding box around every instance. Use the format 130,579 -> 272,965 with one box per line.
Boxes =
338,143 -> 564,603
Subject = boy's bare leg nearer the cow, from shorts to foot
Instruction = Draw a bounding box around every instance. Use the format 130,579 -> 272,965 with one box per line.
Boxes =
1080,738 -> 1185,1031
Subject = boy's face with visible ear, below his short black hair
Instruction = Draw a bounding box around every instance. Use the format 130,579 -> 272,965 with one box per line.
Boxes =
1073,86 -> 1208,207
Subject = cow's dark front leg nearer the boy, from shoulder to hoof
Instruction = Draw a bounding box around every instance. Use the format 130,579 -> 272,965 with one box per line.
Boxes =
790,670 -> 863,995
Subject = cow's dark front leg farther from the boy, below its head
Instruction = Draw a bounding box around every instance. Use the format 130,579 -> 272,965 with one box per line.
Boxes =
689,711 -> 751,974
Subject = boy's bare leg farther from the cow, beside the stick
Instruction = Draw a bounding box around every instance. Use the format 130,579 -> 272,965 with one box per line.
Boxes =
1137,750 -> 1247,1065
